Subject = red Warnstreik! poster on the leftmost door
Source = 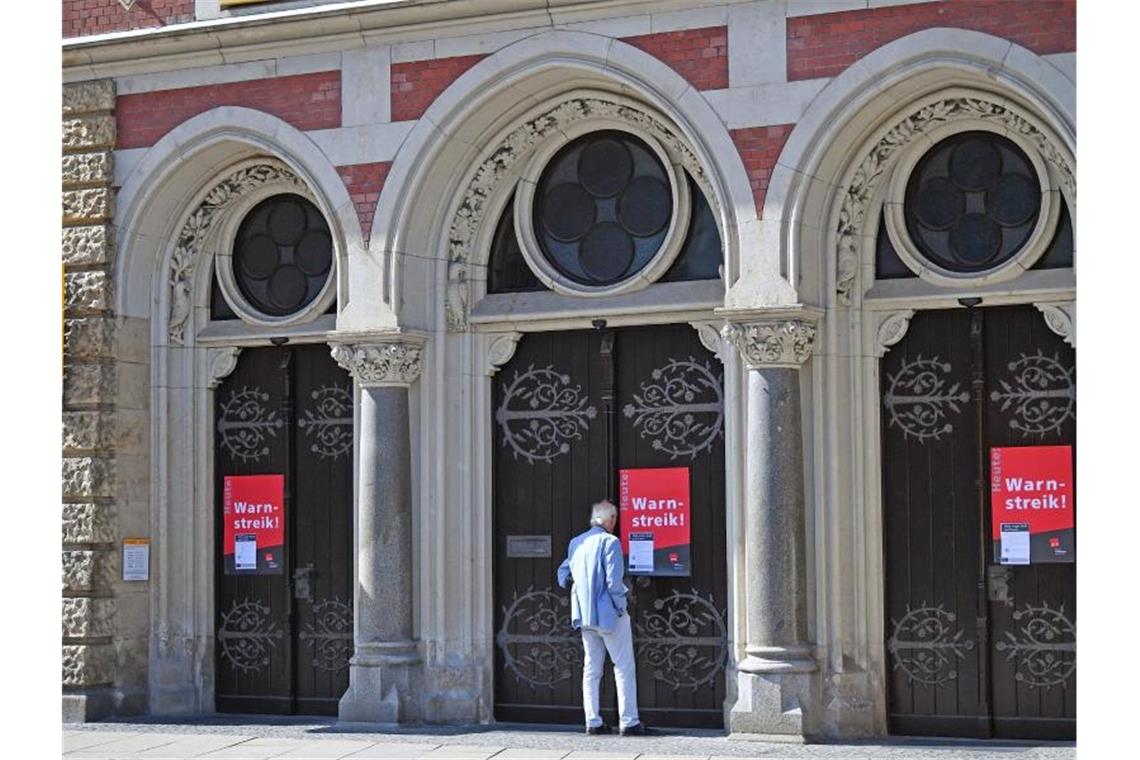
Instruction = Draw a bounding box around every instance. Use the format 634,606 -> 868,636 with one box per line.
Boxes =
222,475 -> 285,575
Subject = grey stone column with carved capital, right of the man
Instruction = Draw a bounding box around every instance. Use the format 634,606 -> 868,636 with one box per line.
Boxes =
723,319 -> 816,741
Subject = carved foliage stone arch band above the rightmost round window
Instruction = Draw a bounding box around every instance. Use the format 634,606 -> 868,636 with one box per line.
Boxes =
834,89 -> 1076,305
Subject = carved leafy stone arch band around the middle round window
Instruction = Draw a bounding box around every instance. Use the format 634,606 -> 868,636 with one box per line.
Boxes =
447,90 -> 720,332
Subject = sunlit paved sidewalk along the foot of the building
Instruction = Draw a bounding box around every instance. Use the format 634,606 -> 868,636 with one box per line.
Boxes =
64,716 -> 1076,760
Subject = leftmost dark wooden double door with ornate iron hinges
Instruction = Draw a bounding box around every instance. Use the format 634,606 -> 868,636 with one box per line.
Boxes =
214,345 -> 352,714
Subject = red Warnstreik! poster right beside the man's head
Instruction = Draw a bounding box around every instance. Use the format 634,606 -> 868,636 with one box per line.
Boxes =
618,467 -> 692,575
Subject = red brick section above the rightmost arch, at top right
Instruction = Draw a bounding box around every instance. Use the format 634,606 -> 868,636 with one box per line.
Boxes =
788,0 -> 1076,81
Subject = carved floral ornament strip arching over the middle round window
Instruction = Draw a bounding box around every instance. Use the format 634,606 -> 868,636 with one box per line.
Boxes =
447,93 -> 719,332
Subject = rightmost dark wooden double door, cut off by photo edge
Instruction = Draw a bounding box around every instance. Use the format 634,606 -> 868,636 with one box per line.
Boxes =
881,307 -> 1076,738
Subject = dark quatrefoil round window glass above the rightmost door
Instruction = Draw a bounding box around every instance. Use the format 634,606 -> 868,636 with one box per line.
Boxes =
904,132 -> 1041,272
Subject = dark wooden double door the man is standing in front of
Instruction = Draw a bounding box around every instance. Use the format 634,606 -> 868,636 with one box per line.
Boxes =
494,325 -> 727,727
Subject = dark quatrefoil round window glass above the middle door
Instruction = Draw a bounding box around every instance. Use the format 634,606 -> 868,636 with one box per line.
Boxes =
534,130 -> 673,286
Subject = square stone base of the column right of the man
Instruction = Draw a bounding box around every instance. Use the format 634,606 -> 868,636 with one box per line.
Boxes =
728,663 -> 816,742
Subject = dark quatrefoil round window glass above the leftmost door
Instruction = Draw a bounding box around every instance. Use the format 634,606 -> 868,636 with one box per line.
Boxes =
234,195 -> 333,317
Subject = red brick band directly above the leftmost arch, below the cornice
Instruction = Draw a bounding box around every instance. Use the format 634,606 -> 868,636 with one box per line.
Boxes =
115,71 -> 341,148
